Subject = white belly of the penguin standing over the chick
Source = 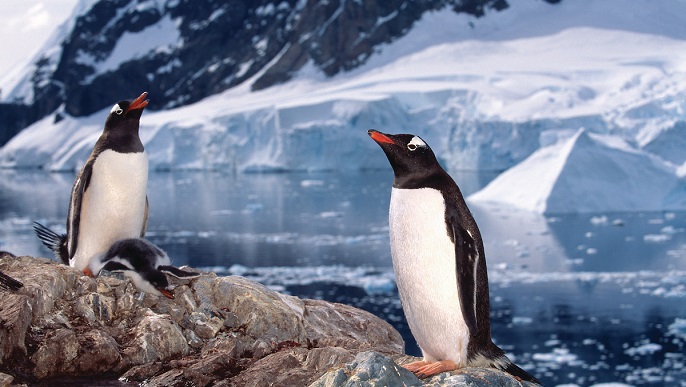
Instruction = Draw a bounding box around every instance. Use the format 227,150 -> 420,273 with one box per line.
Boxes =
70,150 -> 148,270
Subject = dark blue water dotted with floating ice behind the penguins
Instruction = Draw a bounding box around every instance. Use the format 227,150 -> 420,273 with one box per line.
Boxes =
0,169 -> 686,386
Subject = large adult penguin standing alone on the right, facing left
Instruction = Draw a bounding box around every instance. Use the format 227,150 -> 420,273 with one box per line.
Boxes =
368,130 -> 540,384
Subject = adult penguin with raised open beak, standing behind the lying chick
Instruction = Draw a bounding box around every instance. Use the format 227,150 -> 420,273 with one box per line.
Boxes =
36,93 -> 148,275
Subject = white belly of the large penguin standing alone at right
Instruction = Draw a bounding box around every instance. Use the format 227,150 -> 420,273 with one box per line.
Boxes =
389,188 -> 469,366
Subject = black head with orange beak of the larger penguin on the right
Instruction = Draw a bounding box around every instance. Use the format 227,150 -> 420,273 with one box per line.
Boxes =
367,129 -> 445,188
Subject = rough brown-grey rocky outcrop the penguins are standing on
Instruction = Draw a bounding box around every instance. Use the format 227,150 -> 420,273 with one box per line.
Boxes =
0,254 -> 536,386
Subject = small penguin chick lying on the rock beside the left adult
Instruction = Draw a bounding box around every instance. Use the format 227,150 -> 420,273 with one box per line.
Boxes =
89,238 -> 200,299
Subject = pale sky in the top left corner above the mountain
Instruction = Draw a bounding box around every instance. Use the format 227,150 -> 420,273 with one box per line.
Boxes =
0,0 -> 78,78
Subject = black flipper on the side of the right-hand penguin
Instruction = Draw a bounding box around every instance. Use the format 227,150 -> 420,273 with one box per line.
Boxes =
450,221 -> 479,336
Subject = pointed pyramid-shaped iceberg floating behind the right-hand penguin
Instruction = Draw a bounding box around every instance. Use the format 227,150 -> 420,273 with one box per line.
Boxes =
468,129 -> 686,214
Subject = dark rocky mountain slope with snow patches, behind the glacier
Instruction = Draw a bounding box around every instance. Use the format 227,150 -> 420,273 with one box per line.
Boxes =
0,0 -> 520,144
